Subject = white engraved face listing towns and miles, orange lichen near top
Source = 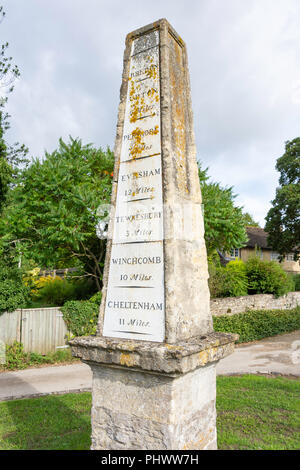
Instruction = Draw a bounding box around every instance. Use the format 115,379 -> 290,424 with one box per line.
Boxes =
103,31 -> 165,342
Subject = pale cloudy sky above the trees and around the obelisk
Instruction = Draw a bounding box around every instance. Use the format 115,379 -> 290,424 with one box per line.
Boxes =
0,0 -> 300,225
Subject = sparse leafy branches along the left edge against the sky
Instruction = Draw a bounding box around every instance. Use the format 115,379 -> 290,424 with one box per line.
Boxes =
0,6 -> 28,211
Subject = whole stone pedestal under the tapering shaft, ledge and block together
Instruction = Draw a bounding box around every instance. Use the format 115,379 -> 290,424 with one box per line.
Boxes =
70,333 -> 238,450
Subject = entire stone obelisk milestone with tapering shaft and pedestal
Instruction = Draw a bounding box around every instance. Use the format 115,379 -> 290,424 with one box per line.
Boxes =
70,19 -> 236,450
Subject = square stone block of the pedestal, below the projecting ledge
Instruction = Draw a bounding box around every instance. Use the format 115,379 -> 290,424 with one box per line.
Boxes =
92,365 -> 216,450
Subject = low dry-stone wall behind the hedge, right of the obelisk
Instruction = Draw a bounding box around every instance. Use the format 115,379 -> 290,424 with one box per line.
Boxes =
210,292 -> 300,317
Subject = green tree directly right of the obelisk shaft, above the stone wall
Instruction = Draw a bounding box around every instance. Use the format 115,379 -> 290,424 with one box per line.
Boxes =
199,165 -> 247,256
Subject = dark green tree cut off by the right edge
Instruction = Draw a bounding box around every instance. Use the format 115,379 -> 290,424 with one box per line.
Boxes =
265,137 -> 300,260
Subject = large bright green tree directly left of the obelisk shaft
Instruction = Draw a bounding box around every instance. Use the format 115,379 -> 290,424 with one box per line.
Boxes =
0,137 -> 114,290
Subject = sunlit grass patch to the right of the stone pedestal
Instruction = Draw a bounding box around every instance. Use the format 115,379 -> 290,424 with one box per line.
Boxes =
217,375 -> 300,450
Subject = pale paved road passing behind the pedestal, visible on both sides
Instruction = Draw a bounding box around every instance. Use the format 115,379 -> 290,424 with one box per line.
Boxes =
0,330 -> 300,401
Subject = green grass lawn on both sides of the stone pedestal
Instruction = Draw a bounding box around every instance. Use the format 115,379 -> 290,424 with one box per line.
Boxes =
0,376 -> 300,450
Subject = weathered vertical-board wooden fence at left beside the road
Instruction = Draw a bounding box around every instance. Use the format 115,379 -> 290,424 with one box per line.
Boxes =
0,307 -> 68,354
